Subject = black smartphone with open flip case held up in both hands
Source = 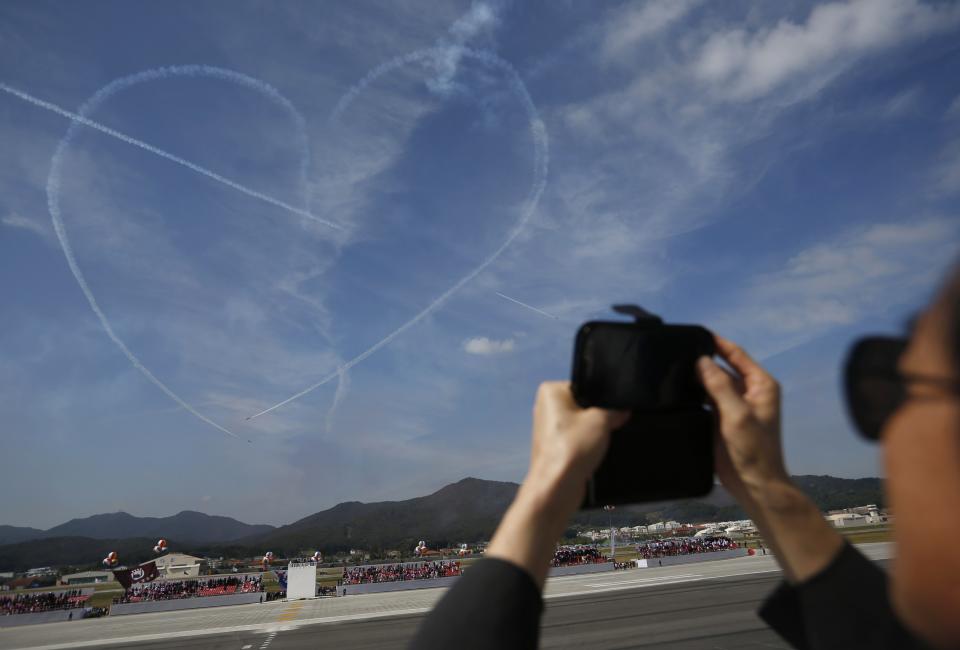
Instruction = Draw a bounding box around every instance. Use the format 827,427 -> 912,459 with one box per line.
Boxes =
571,310 -> 716,508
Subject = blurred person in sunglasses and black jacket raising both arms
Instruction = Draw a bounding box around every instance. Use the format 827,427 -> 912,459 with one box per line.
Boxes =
411,267 -> 960,649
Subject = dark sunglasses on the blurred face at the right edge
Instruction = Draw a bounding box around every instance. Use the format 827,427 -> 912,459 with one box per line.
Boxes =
844,336 -> 960,440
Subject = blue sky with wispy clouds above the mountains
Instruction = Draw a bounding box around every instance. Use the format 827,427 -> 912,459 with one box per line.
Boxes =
0,0 -> 960,527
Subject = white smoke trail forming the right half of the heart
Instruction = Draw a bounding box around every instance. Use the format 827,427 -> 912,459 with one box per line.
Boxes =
247,47 -> 549,420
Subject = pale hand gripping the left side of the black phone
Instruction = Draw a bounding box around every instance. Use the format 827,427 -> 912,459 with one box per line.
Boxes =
524,381 -> 630,508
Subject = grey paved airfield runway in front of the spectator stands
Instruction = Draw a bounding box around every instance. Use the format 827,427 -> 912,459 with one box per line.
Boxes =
0,543 -> 892,650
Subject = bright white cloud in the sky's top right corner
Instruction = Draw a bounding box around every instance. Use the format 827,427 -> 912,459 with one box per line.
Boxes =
694,0 -> 960,100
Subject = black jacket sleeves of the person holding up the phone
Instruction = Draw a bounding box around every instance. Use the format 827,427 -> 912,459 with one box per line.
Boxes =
410,545 -> 928,650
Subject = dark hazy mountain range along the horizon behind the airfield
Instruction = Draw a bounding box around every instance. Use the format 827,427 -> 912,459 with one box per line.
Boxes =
0,475 -> 884,570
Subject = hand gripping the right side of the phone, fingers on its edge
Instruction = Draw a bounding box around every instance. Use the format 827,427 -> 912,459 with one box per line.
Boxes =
697,334 -> 790,506
